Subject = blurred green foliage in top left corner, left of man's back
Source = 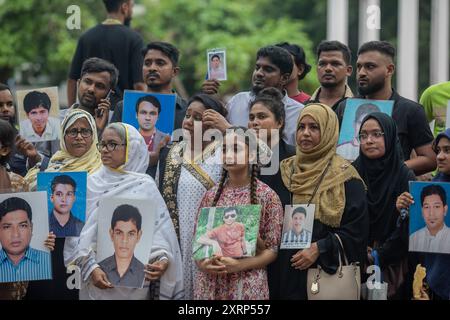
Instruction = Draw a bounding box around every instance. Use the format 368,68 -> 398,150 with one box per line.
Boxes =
0,0 -> 105,84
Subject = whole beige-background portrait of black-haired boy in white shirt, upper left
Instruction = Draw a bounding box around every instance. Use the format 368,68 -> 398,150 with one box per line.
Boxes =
16,87 -> 61,142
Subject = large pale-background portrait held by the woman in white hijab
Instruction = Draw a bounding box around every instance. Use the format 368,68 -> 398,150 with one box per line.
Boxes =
97,198 -> 156,288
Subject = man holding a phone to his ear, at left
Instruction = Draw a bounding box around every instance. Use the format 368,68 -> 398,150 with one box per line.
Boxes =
71,58 -> 118,137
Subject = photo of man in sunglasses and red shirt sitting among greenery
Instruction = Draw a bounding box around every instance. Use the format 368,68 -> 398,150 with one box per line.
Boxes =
193,205 -> 261,260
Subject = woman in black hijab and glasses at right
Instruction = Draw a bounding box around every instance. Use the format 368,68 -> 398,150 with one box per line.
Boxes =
353,112 -> 415,299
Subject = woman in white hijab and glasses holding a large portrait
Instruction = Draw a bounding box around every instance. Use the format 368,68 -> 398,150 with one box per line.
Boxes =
66,123 -> 184,300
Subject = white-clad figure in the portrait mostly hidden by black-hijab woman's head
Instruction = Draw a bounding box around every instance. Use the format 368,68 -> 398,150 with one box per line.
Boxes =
336,103 -> 380,161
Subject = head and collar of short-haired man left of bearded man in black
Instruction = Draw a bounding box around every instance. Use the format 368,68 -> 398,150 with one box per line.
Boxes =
307,41 -> 353,110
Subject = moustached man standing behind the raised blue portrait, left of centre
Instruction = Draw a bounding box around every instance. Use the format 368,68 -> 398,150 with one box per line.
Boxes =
111,42 -> 187,129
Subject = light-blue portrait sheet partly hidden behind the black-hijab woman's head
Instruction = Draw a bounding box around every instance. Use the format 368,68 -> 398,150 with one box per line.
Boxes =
336,98 -> 394,161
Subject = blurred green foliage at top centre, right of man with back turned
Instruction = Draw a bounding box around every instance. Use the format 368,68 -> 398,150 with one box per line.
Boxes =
133,0 -> 318,94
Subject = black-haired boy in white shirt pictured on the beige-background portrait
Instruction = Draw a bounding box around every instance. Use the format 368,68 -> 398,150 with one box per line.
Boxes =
20,91 -> 60,142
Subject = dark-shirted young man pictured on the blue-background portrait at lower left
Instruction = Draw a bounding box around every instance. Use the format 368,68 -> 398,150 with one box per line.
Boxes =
49,175 -> 84,238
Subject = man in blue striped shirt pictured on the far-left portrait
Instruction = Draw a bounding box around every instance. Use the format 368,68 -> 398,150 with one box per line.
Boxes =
0,197 -> 52,282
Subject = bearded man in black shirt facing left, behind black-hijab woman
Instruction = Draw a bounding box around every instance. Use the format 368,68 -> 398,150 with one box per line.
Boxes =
335,41 -> 436,175
